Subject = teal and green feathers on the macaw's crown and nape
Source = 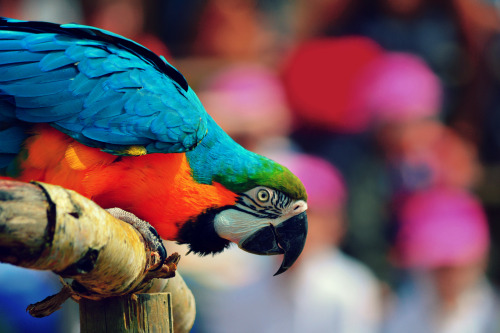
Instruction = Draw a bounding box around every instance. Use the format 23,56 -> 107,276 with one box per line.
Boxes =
186,116 -> 307,200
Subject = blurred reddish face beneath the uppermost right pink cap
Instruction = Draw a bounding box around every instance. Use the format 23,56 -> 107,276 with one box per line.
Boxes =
377,119 -> 481,196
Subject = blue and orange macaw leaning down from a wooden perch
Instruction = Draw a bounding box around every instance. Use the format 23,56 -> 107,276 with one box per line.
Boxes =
0,18 -> 307,275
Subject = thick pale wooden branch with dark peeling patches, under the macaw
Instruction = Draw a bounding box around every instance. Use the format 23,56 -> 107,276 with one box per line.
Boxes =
0,180 -> 194,332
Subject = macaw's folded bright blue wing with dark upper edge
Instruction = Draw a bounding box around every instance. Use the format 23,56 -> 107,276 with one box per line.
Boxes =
0,18 -> 207,157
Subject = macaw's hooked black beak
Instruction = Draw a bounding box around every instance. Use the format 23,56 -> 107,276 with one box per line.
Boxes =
240,212 -> 307,276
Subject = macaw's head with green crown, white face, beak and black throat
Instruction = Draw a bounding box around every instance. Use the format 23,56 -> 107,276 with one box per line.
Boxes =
178,144 -> 307,275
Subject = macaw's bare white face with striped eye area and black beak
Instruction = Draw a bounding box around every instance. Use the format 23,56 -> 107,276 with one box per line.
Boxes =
214,186 -> 307,275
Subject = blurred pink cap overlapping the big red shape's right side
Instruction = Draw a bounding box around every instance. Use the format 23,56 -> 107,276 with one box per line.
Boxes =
353,52 -> 443,126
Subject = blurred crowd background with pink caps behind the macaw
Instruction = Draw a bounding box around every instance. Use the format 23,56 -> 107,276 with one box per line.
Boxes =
0,0 -> 500,333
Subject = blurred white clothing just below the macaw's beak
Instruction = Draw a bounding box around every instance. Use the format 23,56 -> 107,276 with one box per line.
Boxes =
197,250 -> 381,333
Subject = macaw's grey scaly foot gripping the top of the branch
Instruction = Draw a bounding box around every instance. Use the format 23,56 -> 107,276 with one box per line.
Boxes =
106,208 -> 167,271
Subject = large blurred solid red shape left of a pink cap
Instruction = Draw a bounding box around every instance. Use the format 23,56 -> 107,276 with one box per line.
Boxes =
283,36 -> 383,132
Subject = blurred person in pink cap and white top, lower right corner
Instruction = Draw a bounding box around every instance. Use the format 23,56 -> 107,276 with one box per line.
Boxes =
383,187 -> 500,333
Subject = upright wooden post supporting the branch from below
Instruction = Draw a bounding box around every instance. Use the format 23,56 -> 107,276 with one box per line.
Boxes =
80,293 -> 174,333
